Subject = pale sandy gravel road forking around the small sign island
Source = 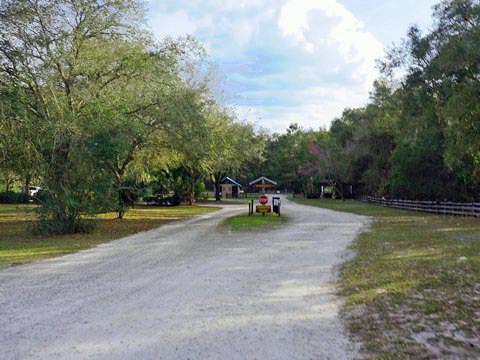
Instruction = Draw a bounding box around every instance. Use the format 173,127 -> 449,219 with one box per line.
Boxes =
0,200 -> 366,359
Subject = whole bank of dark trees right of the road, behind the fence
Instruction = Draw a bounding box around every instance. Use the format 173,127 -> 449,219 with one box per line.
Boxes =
256,0 -> 480,201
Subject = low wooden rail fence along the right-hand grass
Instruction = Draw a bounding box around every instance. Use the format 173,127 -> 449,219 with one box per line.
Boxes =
361,196 -> 480,217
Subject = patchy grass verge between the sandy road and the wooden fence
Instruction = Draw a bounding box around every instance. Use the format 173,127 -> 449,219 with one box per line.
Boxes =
288,199 -> 480,358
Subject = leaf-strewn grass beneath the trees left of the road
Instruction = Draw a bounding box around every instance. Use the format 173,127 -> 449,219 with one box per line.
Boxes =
0,205 -> 216,268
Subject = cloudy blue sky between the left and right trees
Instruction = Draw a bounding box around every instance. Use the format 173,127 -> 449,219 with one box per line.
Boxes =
148,0 -> 438,132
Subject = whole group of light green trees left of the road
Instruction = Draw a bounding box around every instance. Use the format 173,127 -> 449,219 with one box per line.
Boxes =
0,0 -> 254,233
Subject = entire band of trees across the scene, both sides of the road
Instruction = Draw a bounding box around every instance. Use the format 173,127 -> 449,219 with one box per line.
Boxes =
0,0 -> 480,236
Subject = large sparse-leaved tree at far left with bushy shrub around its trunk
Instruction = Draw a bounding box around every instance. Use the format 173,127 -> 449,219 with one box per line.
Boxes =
0,0 -> 154,232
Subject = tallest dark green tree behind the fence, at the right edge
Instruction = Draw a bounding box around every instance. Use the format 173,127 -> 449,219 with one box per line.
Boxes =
384,0 -> 480,200
